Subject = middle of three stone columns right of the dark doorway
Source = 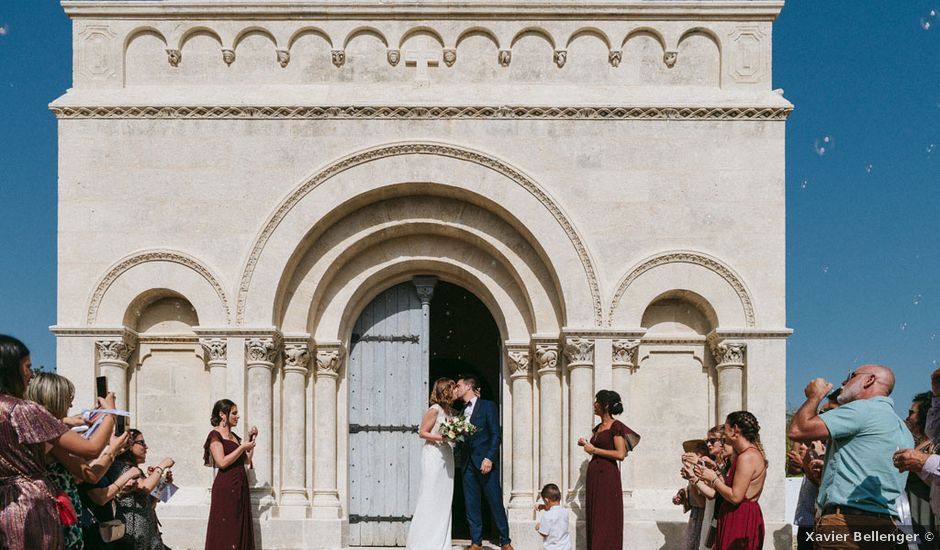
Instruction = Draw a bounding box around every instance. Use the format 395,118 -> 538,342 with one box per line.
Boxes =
535,343 -> 563,487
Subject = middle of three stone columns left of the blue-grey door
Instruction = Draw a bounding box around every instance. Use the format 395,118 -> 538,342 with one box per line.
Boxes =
280,342 -> 310,515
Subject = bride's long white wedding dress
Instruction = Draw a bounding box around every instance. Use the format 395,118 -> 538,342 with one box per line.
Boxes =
407,404 -> 454,550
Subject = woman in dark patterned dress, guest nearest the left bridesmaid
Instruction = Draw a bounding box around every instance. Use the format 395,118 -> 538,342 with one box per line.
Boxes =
108,429 -> 174,550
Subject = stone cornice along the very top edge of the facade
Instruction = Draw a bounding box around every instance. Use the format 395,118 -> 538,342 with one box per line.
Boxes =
62,0 -> 783,21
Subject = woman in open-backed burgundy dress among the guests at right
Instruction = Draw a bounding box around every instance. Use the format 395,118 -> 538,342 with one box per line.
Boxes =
695,411 -> 767,550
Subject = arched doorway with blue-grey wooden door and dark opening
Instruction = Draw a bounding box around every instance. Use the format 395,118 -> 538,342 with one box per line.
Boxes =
347,277 -> 501,546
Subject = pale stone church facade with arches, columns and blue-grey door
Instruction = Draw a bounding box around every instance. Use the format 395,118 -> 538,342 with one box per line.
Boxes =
51,0 -> 792,550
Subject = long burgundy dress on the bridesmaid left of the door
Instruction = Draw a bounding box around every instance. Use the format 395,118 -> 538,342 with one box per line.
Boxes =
204,430 -> 255,550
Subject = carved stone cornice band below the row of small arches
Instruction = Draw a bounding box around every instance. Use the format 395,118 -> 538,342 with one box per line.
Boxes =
50,105 -> 793,120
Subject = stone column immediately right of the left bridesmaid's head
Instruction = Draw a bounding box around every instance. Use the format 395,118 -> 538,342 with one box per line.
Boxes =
245,333 -> 281,504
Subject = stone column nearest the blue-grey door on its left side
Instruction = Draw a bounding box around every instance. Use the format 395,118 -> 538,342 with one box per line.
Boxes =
313,344 -> 344,519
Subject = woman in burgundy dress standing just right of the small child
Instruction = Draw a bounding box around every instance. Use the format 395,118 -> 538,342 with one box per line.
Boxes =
578,390 -> 639,550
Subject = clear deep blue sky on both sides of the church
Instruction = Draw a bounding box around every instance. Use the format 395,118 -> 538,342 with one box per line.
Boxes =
0,0 -> 940,411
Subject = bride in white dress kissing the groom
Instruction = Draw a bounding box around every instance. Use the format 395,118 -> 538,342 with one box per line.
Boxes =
407,378 -> 456,550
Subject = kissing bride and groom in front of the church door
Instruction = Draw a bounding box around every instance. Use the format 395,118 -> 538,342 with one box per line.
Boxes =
407,376 -> 512,550
